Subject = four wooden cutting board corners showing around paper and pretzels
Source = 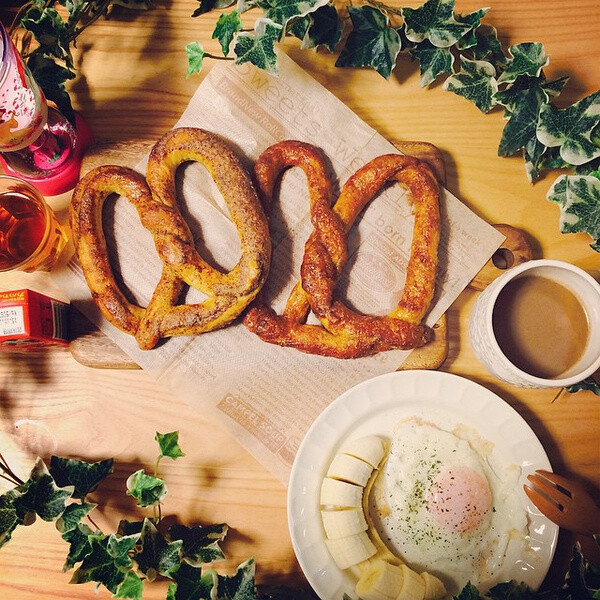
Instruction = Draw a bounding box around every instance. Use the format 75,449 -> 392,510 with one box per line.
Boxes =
69,140 -> 448,369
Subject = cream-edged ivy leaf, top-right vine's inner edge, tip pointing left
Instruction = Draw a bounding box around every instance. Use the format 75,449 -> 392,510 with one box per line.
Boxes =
444,56 -> 498,113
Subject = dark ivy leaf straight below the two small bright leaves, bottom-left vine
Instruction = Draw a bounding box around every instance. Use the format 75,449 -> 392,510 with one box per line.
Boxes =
135,519 -> 183,581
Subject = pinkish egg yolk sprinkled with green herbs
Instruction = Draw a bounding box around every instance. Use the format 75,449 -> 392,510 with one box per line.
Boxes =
427,466 -> 492,533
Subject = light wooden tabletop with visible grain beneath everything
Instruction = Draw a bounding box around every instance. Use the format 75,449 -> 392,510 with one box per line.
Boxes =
0,0 -> 600,600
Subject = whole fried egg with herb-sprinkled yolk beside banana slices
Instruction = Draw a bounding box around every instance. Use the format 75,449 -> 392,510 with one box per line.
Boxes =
369,419 -> 527,593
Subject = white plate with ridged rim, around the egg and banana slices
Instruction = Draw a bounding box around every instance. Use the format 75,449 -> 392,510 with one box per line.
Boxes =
288,371 -> 558,600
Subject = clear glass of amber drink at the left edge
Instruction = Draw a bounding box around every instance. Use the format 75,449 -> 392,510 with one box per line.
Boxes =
0,175 -> 67,273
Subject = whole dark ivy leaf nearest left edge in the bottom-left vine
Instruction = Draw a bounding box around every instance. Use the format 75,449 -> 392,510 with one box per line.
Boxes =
14,458 -> 74,521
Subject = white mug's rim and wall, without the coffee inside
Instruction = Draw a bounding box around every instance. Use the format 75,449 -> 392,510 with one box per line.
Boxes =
469,259 -> 600,388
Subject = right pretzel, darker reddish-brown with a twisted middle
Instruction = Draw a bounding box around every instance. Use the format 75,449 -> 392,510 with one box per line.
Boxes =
244,142 -> 440,358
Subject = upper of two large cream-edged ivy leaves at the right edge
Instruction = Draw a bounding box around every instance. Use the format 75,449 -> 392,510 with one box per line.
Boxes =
537,90 -> 600,165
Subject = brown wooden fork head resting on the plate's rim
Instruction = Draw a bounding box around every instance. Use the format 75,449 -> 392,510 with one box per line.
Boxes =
523,470 -> 600,536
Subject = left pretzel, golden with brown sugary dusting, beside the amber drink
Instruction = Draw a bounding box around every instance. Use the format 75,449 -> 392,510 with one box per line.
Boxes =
70,128 -> 271,350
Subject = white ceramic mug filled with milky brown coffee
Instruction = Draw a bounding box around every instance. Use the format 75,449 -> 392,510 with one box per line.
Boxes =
469,259 -> 600,388
